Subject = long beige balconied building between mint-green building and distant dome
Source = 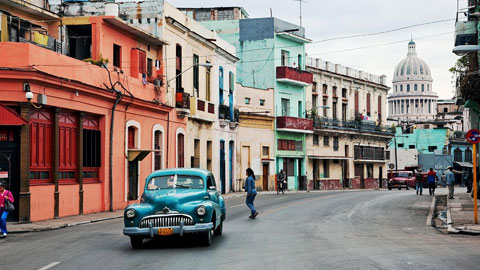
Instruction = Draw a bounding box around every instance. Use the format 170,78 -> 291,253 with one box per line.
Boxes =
306,58 -> 393,189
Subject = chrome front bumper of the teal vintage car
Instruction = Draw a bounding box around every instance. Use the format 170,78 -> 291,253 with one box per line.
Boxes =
123,222 -> 213,237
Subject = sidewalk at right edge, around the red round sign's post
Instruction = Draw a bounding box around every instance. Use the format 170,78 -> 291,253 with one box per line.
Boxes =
447,186 -> 480,235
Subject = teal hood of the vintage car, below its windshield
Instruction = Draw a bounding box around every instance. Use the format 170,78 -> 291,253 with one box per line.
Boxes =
151,189 -> 206,212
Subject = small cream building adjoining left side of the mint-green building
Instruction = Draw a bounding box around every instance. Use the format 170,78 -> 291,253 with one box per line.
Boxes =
236,84 -> 276,191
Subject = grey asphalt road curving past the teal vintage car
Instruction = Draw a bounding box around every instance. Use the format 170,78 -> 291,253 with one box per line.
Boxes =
0,190 -> 480,270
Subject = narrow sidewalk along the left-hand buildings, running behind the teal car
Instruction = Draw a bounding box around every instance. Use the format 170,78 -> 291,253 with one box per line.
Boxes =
7,190 -> 376,234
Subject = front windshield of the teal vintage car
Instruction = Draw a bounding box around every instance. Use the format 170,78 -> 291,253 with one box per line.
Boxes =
147,175 -> 204,190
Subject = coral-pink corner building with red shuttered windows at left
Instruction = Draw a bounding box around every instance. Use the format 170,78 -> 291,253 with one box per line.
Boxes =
0,4 -> 186,221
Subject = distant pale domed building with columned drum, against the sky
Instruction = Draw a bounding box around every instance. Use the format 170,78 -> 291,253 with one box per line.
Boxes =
388,40 -> 438,124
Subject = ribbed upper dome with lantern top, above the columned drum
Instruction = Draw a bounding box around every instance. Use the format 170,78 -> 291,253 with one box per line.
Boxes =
393,40 -> 432,83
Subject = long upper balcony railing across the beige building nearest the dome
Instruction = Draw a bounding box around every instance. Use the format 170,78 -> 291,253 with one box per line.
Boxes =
313,117 -> 395,135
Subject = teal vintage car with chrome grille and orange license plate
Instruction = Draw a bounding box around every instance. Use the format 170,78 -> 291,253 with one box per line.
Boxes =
123,169 -> 226,249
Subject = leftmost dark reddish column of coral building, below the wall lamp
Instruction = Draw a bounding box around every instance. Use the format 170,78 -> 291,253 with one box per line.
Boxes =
18,103 -> 31,222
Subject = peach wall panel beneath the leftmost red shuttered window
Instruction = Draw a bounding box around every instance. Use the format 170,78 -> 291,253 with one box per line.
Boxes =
30,185 -> 55,221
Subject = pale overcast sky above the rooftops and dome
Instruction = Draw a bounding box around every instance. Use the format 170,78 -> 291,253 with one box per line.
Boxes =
169,0 -> 457,98
